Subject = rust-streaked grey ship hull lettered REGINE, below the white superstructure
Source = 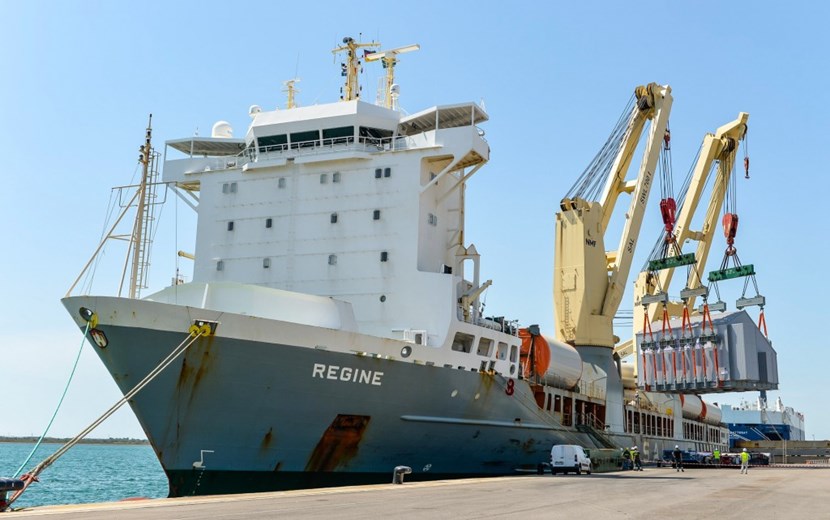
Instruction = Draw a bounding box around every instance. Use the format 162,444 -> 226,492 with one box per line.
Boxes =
64,297 -> 594,496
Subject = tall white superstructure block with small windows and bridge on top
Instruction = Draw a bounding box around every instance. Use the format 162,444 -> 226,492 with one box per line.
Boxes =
164,100 -> 489,346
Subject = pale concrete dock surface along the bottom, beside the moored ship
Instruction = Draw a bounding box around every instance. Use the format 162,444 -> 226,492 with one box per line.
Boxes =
8,467 -> 830,520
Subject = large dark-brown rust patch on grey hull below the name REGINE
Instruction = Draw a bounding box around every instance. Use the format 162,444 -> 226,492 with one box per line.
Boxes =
305,415 -> 371,471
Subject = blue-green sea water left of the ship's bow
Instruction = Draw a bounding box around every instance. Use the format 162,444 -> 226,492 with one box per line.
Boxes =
0,442 -> 167,508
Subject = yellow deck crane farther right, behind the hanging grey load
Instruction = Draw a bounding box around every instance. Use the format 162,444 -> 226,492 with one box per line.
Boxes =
615,112 -> 749,363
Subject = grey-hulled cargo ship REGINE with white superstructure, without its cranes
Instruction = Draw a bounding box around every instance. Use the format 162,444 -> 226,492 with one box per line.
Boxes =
58,38 -> 764,496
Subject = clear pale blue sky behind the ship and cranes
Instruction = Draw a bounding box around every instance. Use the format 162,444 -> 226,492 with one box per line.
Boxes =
0,0 -> 830,439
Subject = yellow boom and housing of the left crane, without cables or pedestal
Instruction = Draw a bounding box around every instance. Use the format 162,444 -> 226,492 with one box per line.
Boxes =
553,83 -> 672,347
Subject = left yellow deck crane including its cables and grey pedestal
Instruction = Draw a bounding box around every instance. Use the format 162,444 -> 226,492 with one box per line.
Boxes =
553,83 -> 672,431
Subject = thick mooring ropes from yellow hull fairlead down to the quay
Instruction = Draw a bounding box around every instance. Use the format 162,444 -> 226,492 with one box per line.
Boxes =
0,326 -> 211,512
